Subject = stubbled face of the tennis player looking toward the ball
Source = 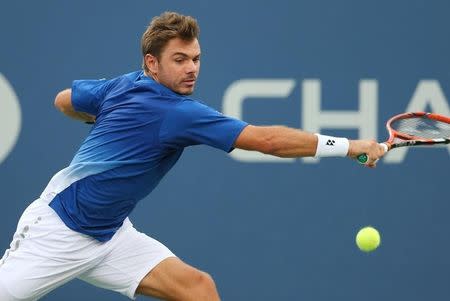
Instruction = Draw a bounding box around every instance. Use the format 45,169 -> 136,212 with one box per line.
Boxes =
146,38 -> 200,95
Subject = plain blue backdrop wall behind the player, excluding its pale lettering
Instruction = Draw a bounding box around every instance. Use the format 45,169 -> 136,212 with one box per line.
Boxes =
0,0 -> 450,301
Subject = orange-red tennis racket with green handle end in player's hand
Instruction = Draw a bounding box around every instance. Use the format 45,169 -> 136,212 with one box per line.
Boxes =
357,112 -> 450,164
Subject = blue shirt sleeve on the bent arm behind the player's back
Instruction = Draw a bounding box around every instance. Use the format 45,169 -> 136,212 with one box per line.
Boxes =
72,79 -> 110,116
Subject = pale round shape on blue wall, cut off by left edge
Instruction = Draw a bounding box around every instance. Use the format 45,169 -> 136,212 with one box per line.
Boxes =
0,73 -> 22,163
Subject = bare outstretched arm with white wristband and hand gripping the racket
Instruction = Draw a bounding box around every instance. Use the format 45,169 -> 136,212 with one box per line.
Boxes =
234,125 -> 385,167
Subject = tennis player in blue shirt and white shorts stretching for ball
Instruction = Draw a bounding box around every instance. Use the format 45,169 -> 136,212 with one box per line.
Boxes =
0,13 -> 384,301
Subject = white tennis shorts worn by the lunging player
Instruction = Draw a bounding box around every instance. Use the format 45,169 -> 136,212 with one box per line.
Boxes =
0,199 -> 175,301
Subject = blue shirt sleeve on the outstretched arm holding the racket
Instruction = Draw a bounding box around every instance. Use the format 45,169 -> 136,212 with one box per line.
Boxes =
160,100 -> 248,152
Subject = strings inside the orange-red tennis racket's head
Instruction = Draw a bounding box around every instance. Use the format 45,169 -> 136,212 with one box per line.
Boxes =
391,117 -> 450,139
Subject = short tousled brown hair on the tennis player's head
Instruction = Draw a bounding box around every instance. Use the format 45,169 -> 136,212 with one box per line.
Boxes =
141,12 -> 200,72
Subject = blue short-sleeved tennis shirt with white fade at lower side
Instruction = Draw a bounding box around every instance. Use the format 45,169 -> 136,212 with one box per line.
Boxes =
41,71 -> 247,241
